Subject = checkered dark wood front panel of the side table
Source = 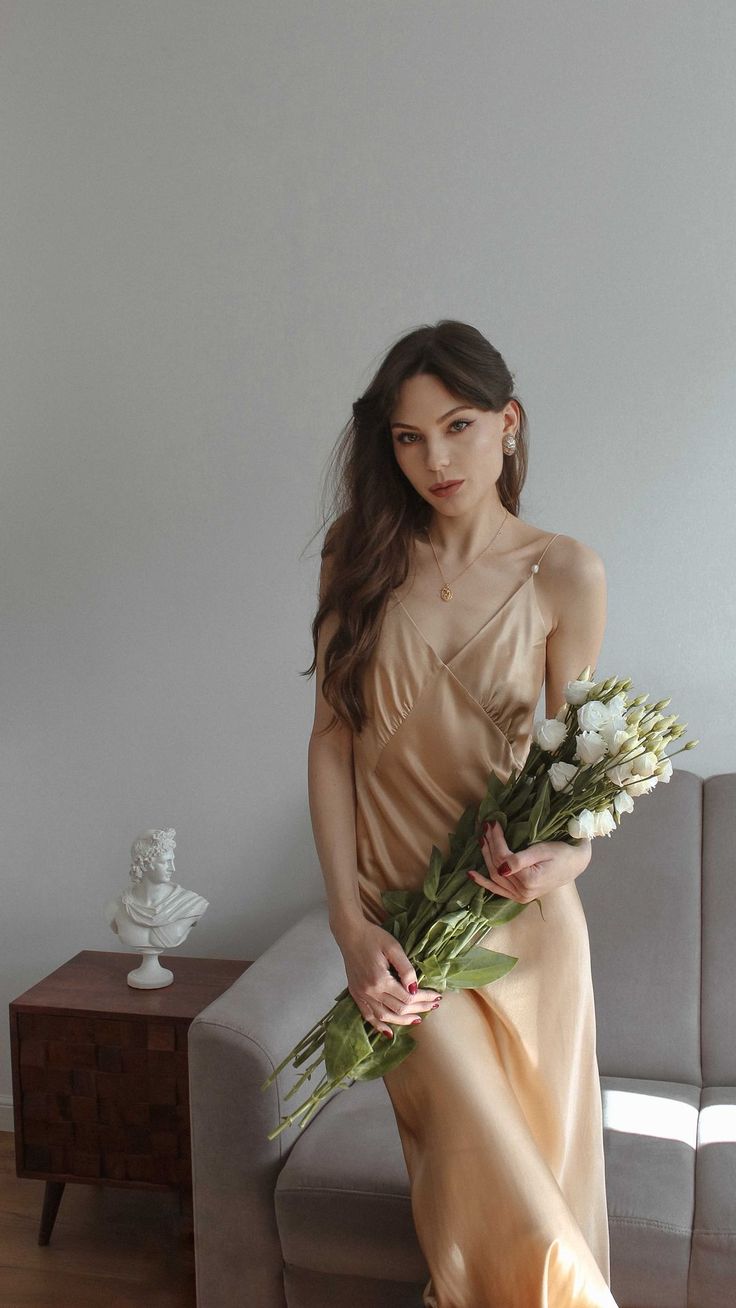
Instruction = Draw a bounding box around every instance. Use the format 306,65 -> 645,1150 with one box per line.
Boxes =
18,1014 -> 191,1185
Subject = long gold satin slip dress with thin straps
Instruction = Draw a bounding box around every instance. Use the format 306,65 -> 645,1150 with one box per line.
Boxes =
354,532 -> 616,1308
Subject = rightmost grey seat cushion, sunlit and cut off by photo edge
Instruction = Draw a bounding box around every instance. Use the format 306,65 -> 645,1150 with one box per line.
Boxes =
689,1086 -> 736,1308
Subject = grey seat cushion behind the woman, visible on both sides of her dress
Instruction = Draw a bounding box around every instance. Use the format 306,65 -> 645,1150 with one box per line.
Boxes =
275,1076 -> 701,1308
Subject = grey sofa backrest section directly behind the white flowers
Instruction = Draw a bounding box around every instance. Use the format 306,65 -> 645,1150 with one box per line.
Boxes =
583,766 -> 700,1086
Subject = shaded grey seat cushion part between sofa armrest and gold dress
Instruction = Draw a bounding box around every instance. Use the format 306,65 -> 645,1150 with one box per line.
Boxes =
275,1079 -> 429,1283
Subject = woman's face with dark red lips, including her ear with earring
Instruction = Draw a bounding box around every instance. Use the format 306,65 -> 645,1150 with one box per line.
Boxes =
391,374 -> 520,517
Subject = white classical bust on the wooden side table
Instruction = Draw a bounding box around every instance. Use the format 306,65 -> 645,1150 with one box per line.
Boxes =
105,827 -> 209,990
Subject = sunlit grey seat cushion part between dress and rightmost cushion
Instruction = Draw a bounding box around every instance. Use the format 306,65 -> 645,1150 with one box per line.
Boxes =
601,1076 -> 701,1308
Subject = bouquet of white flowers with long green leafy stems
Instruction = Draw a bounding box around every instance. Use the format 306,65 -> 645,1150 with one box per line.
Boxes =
261,667 -> 698,1139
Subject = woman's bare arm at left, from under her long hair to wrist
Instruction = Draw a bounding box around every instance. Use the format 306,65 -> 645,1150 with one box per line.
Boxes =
307,559 -> 366,943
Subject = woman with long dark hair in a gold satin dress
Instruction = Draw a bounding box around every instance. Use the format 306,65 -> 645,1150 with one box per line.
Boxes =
309,320 -> 614,1308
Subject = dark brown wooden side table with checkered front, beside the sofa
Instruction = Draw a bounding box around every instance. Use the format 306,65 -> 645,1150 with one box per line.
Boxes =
9,950 -> 252,1244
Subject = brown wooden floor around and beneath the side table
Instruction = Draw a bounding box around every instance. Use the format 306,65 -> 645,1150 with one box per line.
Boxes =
0,1131 -> 196,1308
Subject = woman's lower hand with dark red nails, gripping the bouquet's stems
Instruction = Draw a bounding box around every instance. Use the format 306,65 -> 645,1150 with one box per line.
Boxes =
336,921 -> 442,1037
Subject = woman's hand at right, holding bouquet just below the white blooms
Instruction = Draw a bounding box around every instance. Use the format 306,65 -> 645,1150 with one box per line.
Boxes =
468,823 -> 592,904
